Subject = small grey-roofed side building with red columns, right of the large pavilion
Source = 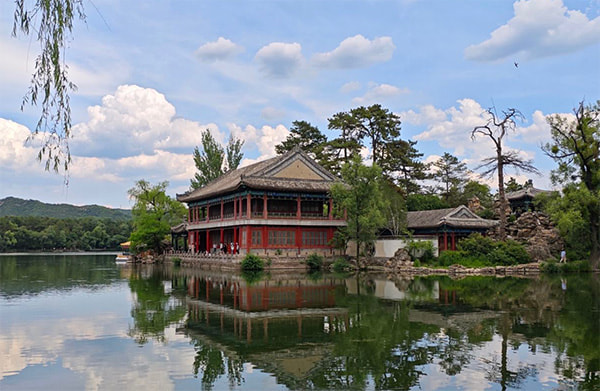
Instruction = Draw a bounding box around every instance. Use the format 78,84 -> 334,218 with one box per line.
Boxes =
406,205 -> 498,251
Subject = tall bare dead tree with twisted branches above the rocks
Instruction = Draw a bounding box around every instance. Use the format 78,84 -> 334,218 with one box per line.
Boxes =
471,107 -> 539,240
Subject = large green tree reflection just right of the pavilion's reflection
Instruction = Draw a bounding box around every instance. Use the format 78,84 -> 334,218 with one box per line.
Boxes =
311,295 -> 439,390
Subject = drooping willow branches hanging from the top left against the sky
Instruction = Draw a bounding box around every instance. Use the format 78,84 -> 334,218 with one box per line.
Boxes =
12,0 -> 85,171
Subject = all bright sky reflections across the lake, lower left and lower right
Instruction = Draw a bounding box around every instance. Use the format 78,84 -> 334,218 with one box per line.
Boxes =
0,270 -> 592,391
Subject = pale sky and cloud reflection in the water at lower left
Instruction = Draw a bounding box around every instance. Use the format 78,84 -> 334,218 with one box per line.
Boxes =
0,281 -> 286,391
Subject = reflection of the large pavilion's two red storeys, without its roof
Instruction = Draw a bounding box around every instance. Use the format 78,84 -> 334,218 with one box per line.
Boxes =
186,274 -> 347,348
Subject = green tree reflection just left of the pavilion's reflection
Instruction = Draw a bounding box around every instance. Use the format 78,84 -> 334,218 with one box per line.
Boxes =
128,273 -> 186,344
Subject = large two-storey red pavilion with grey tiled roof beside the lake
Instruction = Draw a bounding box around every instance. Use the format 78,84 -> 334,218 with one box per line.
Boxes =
177,149 -> 346,255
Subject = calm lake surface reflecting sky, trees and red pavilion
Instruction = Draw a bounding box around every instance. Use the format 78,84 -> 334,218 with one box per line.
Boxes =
0,255 -> 600,391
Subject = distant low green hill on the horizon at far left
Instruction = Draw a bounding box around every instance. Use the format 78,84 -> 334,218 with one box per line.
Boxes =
0,197 -> 131,220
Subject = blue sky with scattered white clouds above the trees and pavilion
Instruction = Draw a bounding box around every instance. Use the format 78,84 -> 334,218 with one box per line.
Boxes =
0,0 -> 600,208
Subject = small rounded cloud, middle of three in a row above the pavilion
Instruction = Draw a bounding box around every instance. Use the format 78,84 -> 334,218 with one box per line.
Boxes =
255,42 -> 304,78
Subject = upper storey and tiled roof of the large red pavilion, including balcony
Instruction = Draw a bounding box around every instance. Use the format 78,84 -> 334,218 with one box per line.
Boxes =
177,149 -> 345,230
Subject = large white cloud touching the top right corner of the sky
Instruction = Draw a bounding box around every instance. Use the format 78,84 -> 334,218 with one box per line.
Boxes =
465,0 -> 600,61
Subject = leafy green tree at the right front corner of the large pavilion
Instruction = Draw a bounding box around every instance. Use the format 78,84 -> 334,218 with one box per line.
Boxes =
331,156 -> 387,262
